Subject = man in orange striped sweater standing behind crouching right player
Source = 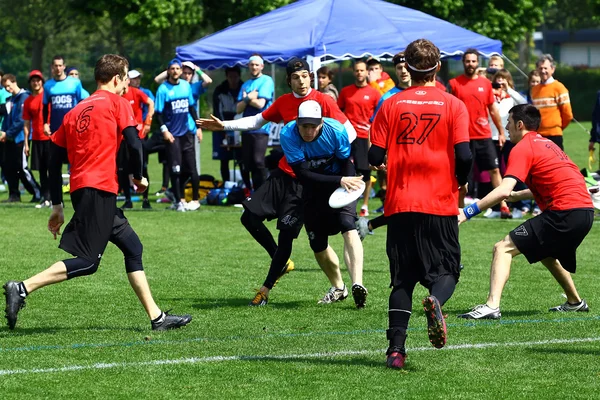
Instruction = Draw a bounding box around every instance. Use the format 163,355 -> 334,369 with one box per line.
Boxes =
531,54 -> 573,150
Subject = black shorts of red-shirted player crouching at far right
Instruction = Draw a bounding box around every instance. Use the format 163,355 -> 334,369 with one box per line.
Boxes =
509,209 -> 594,273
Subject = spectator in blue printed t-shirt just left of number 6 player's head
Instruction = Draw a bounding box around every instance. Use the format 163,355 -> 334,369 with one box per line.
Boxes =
43,56 -> 83,136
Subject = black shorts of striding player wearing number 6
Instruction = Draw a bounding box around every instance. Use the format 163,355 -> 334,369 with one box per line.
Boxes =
58,188 -> 129,262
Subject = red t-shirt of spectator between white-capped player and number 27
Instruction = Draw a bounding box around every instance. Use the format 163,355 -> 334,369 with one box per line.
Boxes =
338,84 -> 381,139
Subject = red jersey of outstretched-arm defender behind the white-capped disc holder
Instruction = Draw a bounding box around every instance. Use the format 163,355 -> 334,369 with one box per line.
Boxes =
262,89 -> 348,177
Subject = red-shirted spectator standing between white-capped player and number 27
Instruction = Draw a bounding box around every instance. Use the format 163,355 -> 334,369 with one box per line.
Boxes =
338,61 -> 381,217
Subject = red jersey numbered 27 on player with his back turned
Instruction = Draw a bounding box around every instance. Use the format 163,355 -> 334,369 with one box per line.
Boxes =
371,86 -> 469,216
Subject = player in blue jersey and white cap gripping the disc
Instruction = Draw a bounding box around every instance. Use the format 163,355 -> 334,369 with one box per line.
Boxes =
281,100 -> 367,308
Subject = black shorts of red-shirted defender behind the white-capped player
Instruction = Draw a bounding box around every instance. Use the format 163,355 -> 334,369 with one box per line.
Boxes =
242,169 -> 304,237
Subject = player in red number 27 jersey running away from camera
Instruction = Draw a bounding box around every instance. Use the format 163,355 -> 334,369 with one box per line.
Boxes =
369,39 -> 471,369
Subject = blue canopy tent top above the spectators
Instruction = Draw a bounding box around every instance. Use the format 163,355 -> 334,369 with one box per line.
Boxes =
177,0 -> 502,70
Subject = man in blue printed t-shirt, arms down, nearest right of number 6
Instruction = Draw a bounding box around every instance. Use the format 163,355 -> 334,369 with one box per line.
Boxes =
154,58 -> 201,211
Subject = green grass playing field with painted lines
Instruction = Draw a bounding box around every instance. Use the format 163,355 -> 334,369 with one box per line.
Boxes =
0,125 -> 600,399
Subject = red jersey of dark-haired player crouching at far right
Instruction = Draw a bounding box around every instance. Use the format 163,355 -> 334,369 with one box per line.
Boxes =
504,132 -> 593,211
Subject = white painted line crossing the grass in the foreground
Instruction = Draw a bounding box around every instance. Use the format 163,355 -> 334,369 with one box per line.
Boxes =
0,337 -> 600,376
